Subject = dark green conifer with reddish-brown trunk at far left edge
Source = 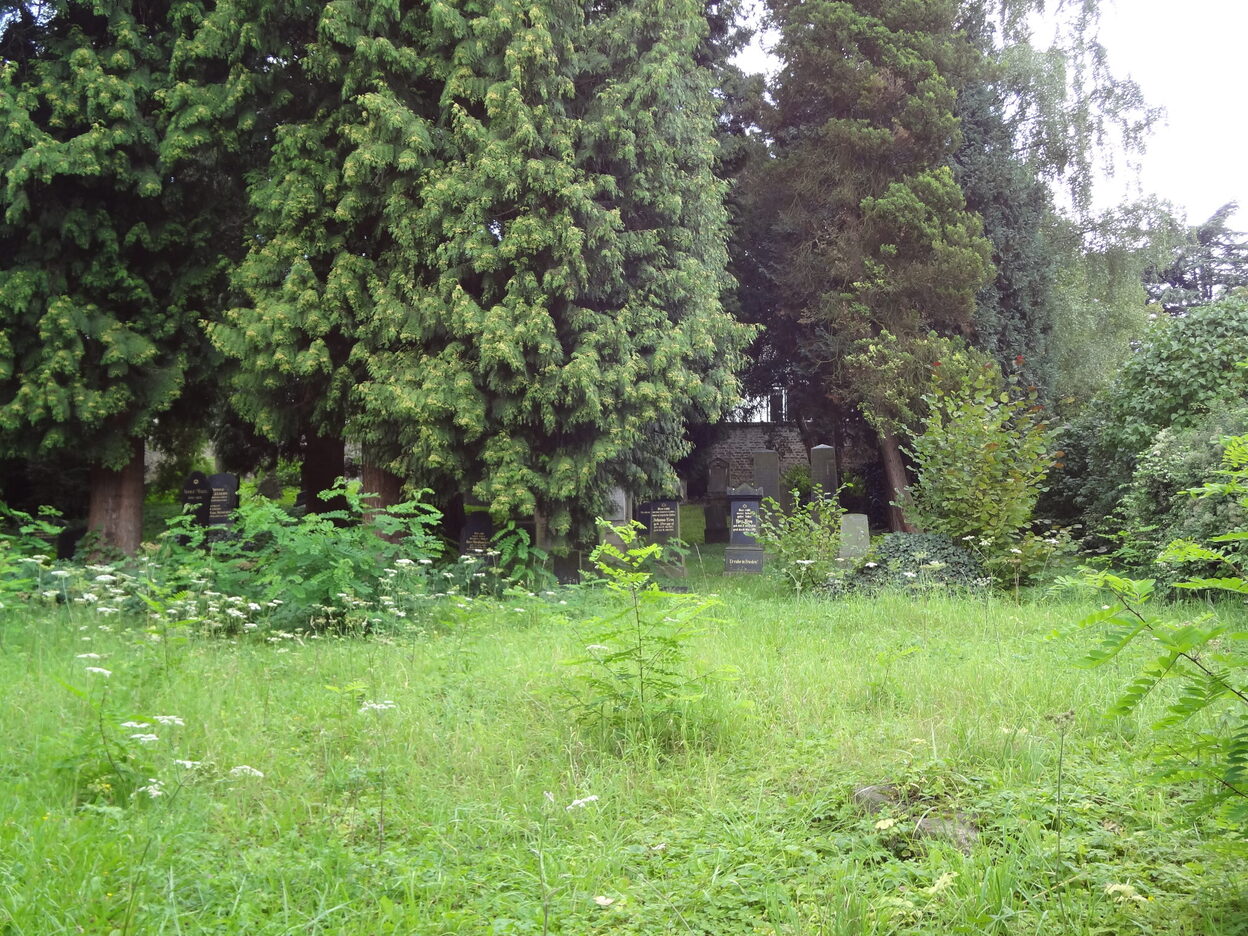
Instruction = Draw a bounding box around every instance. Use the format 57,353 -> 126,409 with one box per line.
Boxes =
0,0 -> 221,552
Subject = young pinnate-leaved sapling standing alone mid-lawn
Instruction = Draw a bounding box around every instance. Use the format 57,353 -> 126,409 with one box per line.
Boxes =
569,520 -> 734,748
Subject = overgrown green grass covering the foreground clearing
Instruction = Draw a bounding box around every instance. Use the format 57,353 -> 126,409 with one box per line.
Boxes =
0,576 -> 1248,936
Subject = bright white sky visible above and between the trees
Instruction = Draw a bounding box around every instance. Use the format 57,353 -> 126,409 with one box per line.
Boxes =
738,0 -> 1248,231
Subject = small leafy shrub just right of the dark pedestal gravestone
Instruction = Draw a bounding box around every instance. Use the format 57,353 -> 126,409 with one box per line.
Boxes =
758,484 -> 845,594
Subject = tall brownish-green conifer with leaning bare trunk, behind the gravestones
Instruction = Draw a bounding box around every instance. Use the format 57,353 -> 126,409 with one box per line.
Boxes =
755,0 -> 988,525
